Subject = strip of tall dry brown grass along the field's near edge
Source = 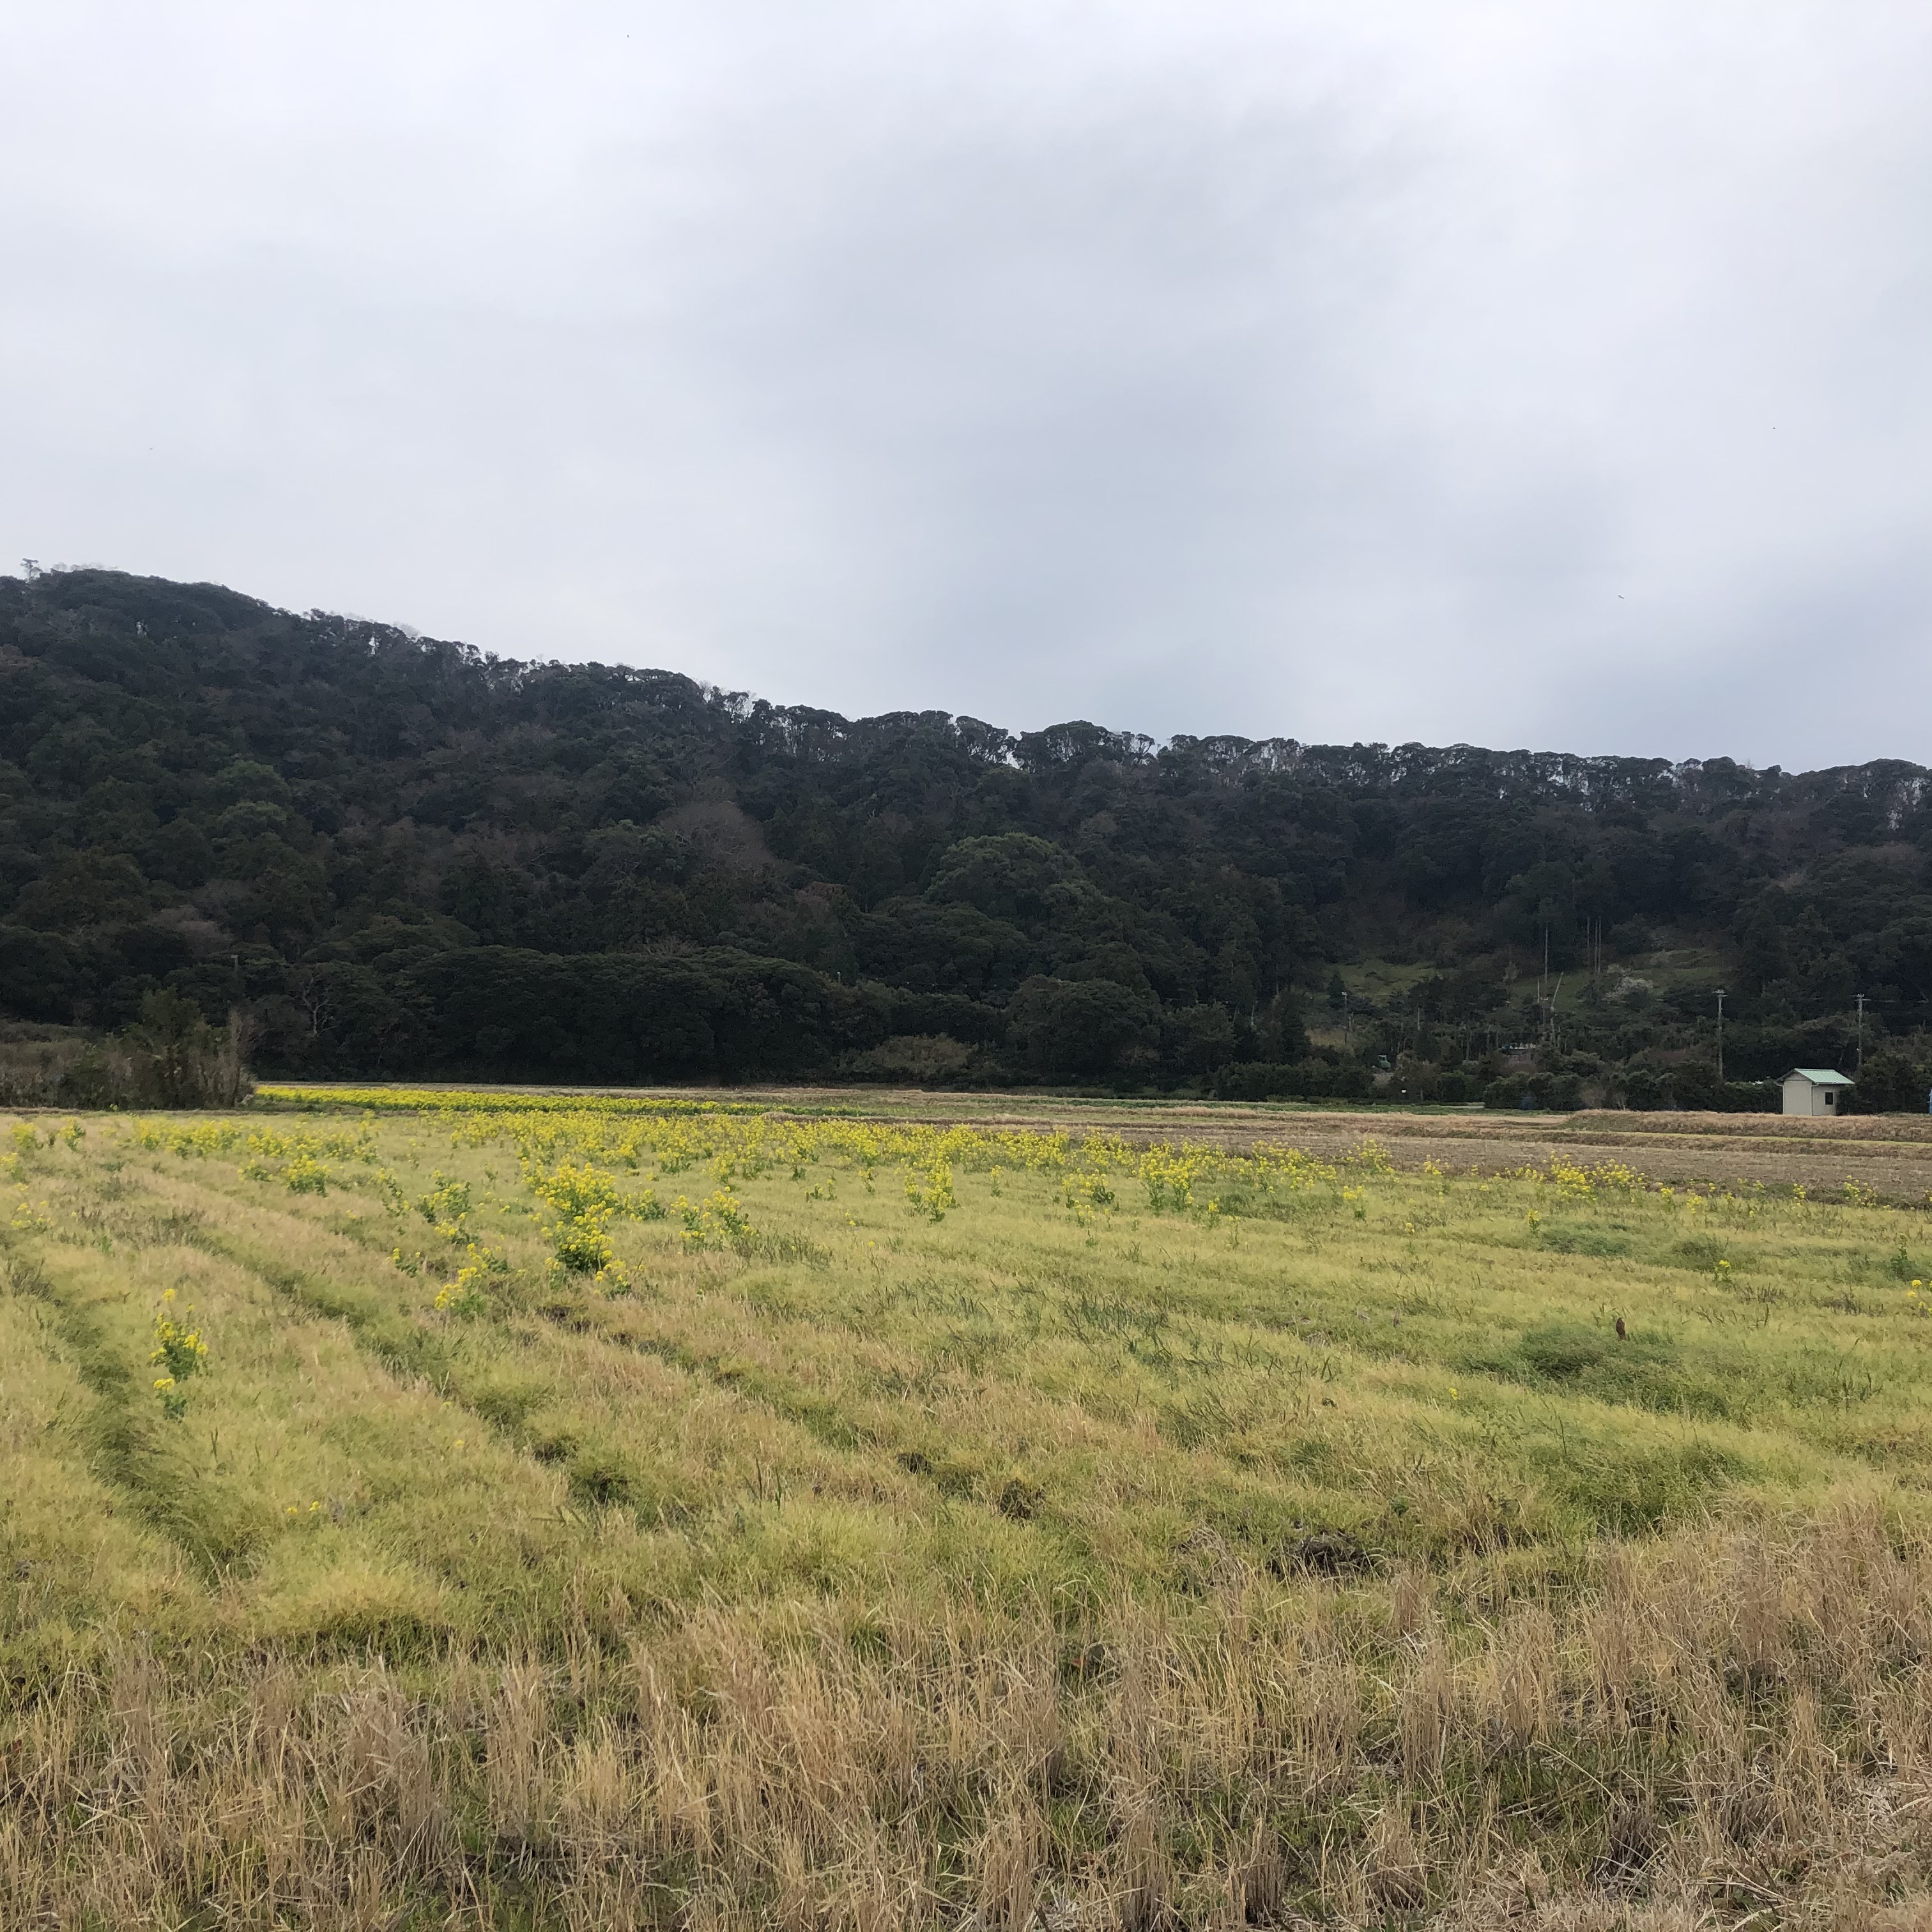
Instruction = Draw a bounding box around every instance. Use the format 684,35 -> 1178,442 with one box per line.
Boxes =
11,1507 -> 1932,1932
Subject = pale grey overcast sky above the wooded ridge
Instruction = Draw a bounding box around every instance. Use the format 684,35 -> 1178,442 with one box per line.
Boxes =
0,0 -> 1932,767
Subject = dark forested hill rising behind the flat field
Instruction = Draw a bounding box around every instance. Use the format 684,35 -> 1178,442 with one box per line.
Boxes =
0,570 -> 1932,1101
